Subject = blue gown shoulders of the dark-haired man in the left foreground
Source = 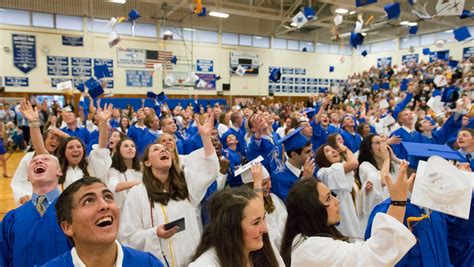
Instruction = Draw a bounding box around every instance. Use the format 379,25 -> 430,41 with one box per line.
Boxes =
42,245 -> 167,267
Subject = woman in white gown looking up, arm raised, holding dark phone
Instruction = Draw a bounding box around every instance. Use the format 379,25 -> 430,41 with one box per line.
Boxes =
120,115 -> 219,266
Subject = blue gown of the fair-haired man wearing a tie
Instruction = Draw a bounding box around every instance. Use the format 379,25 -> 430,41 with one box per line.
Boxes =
0,199 -> 71,267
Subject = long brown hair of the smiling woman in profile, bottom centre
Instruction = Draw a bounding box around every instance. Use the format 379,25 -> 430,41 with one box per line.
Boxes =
191,186 -> 278,267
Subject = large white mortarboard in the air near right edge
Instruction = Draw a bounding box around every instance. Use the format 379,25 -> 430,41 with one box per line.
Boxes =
411,156 -> 472,220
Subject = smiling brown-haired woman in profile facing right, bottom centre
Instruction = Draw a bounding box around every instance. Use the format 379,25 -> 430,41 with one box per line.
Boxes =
189,165 -> 283,267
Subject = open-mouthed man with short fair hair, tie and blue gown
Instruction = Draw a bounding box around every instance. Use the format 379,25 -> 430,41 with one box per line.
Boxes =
0,154 -> 71,266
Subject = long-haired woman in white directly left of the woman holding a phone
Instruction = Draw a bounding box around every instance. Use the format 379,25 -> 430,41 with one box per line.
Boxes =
107,138 -> 143,210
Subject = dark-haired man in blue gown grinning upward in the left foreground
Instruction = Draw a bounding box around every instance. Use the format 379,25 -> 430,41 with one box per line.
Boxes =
44,177 -> 163,267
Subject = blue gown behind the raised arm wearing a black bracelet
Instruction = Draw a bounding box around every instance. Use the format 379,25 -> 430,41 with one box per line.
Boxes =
365,199 -> 452,267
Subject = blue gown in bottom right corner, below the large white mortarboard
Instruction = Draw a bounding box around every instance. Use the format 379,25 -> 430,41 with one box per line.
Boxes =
447,193 -> 474,267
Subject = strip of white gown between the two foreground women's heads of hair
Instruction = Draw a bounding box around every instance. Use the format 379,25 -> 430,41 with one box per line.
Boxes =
266,193 -> 288,251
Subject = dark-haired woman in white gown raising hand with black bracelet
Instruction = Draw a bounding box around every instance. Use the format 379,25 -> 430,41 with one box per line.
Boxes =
281,163 -> 416,267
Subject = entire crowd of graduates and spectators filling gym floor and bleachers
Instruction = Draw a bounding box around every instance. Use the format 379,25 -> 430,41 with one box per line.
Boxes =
0,55 -> 474,266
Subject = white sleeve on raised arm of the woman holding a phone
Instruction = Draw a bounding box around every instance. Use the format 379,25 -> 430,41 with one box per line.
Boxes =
184,148 -> 219,207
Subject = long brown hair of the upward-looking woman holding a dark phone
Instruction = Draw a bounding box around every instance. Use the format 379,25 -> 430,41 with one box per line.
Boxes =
142,144 -> 189,206
